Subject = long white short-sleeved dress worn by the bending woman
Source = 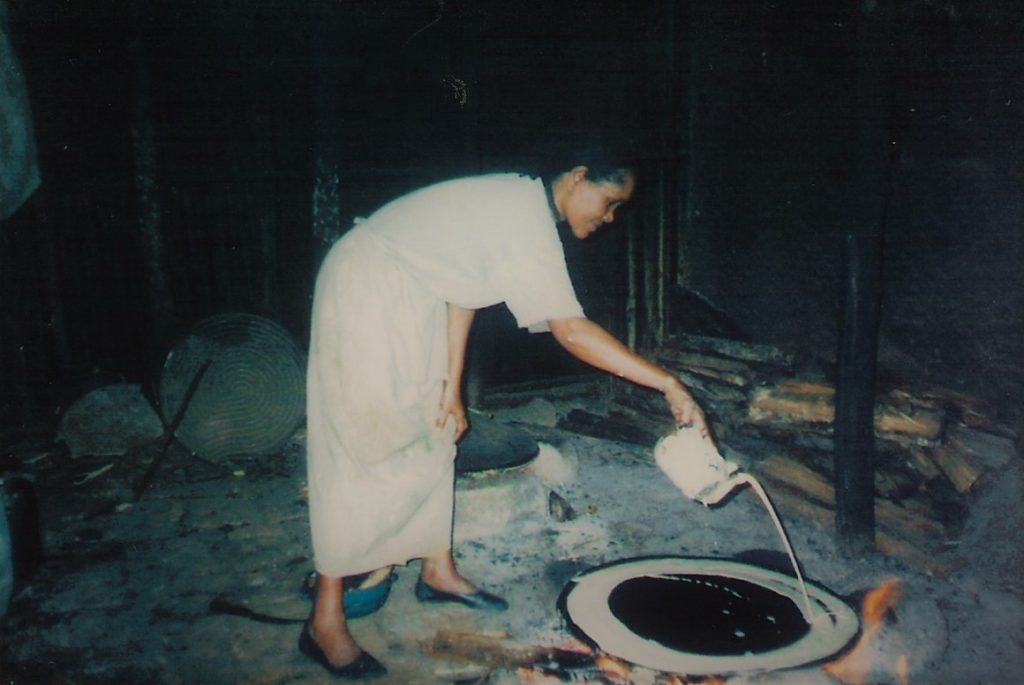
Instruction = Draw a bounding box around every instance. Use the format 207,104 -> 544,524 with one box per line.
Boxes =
307,174 -> 583,576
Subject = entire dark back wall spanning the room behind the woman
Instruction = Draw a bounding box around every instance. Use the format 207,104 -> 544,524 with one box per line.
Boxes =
0,0 -> 1024,428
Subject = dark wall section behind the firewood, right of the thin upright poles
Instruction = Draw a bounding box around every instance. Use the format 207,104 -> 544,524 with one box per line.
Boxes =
684,2 -> 1024,411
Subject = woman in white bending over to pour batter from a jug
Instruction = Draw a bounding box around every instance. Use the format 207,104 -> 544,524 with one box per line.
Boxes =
299,152 -> 707,678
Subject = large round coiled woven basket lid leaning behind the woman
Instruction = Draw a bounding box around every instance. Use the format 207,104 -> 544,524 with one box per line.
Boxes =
160,313 -> 306,460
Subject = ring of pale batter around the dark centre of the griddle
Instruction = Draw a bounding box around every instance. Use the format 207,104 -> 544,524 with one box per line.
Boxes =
563,557 -> 860,676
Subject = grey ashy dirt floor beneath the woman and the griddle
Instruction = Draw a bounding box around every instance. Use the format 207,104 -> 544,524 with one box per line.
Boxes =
0,393 -> 1024,685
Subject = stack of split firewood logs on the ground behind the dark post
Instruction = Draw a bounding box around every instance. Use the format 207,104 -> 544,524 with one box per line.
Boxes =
598,336 -> 1016,574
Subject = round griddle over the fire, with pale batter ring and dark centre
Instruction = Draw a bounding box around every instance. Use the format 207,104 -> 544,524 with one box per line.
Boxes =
559,557 -> 860,676
